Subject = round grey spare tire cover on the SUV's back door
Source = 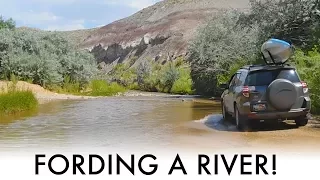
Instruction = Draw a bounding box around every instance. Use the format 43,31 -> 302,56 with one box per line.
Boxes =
267,79 -> 298,110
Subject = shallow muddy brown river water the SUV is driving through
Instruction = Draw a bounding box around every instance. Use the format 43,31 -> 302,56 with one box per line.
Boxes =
0,97 -> 320,151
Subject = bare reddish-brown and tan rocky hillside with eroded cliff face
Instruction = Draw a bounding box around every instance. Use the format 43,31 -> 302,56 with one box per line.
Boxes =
80,0 -> 249,68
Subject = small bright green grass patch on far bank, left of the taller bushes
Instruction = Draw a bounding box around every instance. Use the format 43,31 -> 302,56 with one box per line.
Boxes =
88,80 -> 126,96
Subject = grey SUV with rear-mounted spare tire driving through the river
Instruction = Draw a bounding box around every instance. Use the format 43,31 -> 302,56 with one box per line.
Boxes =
221,64 -> 311,130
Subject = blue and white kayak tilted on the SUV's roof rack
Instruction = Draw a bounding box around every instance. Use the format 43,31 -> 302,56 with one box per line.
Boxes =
261,39 -> 293,64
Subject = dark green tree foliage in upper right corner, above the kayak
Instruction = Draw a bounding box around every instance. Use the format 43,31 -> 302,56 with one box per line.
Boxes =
241,0 -> 320,49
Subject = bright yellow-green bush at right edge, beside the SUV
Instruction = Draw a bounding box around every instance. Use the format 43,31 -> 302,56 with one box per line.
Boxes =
294,48 -> 320,114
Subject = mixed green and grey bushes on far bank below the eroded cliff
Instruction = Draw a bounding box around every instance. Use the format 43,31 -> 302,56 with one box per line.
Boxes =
109,58 -> 193,94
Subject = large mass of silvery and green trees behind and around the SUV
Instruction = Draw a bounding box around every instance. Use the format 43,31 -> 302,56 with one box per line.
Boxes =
189,0 -> 320,113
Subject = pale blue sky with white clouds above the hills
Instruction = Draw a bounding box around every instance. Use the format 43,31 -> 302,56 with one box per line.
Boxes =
0,0 -> 160,31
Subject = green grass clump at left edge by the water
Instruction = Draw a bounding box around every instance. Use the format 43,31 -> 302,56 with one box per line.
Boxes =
0,90 -> 38,114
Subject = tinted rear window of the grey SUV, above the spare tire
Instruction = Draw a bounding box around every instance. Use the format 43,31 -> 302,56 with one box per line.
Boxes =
245,69 -> 300,86
